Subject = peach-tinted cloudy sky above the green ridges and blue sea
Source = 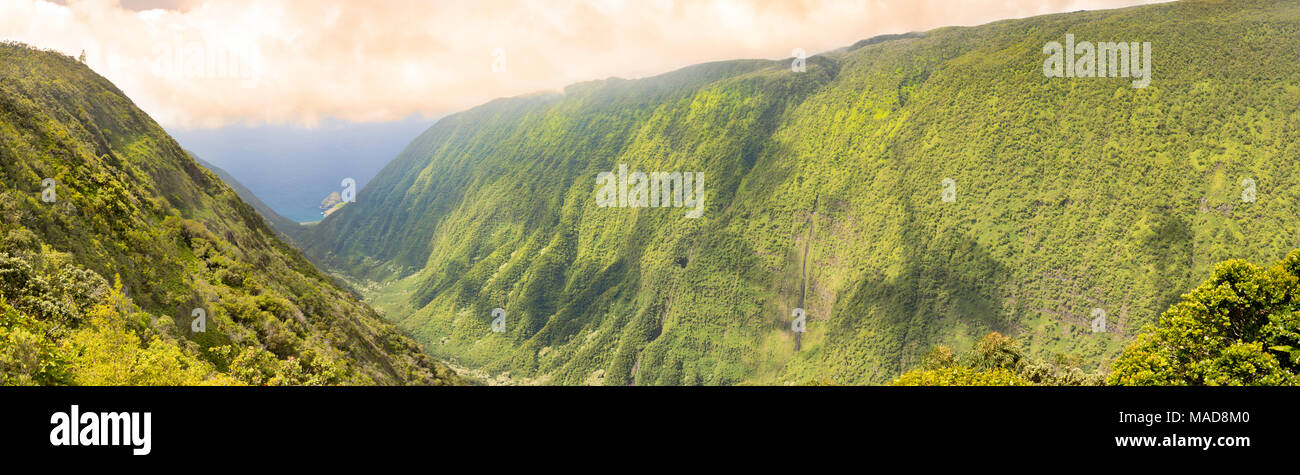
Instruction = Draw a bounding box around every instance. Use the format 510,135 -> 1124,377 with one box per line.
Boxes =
0,0 -> 1153,128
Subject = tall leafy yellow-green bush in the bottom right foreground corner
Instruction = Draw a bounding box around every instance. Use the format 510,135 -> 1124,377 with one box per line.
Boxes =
1108,251 -> 1300,385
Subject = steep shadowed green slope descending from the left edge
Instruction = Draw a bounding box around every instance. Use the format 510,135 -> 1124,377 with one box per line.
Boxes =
0,44 -> 456,384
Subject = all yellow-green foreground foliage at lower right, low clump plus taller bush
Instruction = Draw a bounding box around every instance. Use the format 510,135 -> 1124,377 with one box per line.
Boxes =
894,250 -> 1300,385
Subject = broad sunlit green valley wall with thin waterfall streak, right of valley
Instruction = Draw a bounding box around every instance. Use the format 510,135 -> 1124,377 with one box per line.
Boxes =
304,0 -> 1300,384
